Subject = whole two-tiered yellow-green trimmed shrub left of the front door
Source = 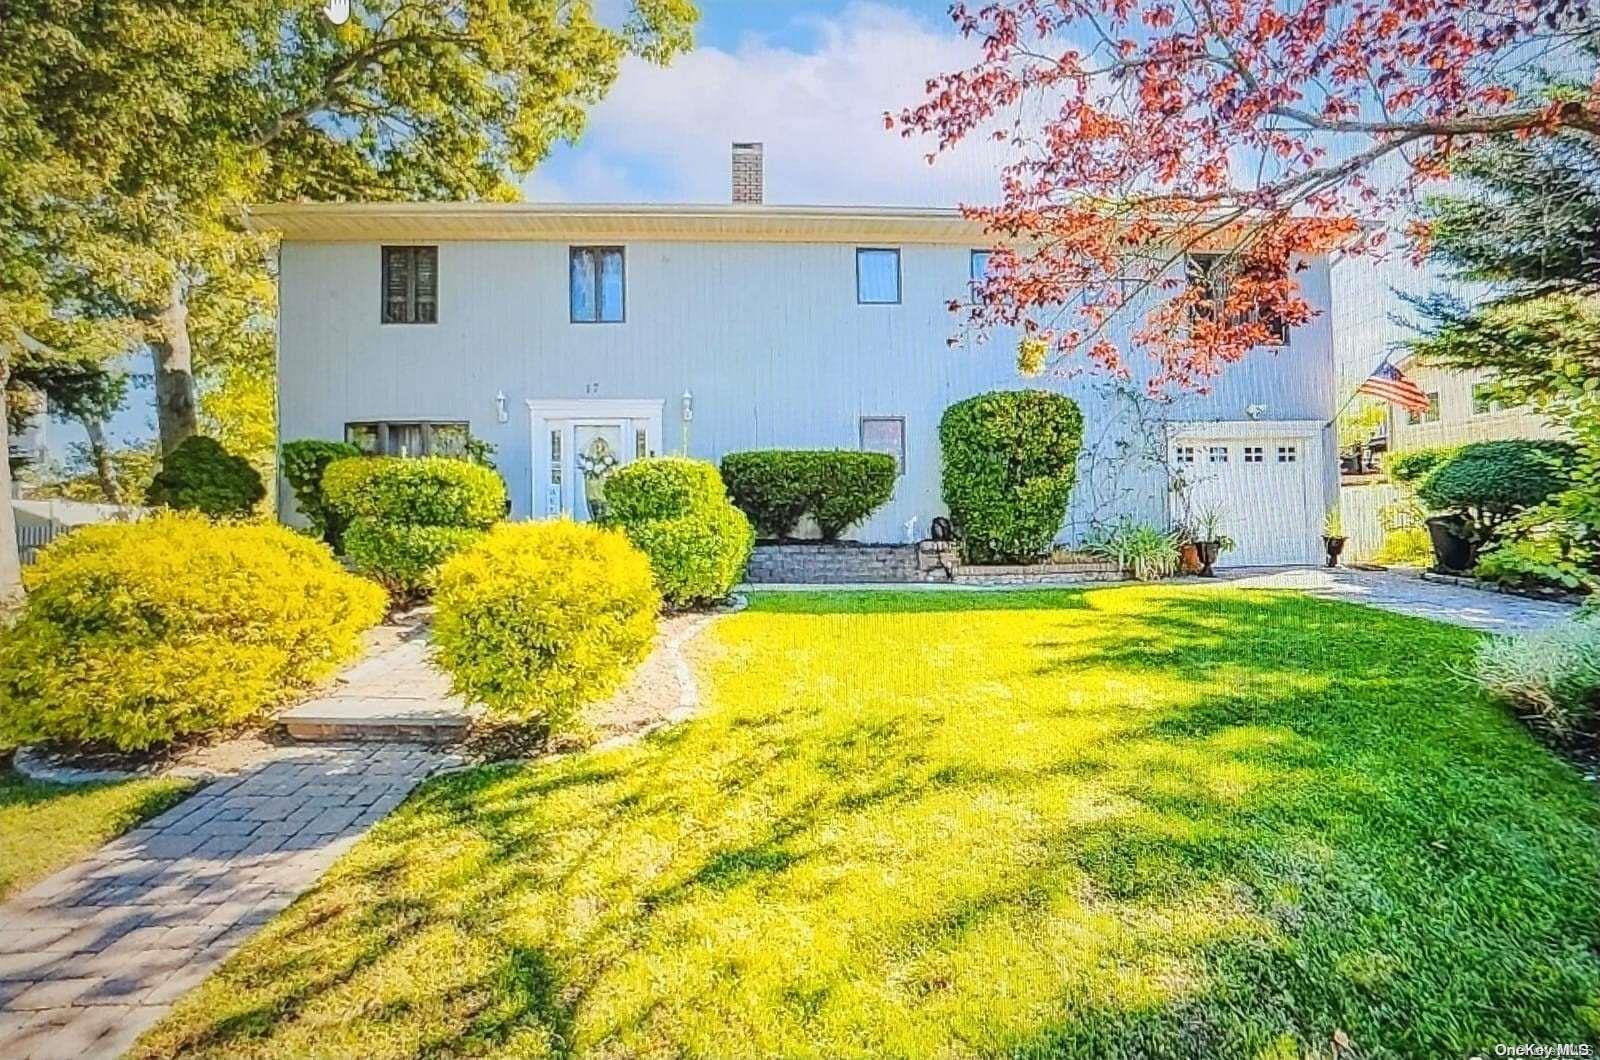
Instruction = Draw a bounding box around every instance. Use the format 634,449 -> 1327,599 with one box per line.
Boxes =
322,456 -> 506,600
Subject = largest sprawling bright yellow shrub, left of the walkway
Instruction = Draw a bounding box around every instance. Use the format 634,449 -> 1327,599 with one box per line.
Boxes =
0,514 -> 384,751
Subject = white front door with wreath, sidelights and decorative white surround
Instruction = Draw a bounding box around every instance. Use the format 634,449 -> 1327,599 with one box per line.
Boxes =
528,399 -> 662,520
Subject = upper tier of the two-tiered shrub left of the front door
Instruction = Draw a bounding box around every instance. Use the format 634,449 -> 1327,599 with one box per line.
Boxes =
322,456 -> 506,530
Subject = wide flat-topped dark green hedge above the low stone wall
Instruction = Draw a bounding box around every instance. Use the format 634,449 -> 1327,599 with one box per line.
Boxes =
722,448 -> 896,541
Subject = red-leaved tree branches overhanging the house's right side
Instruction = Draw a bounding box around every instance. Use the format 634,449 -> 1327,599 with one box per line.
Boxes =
885,0 -> 1600,389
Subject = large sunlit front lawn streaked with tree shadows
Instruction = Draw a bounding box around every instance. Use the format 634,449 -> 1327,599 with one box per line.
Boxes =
128,588 -> 1600,1057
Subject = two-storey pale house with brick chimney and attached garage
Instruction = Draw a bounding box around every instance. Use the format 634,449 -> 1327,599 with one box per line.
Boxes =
248,144 -> 1338,564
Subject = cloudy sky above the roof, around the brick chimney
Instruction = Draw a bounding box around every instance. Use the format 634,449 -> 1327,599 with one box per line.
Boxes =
523,3 -> 997,205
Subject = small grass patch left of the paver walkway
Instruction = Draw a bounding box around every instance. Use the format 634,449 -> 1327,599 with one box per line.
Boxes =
0,769 -> 194,900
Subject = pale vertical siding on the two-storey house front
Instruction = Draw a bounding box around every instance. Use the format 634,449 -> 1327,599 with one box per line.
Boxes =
278,240 -> 1338,541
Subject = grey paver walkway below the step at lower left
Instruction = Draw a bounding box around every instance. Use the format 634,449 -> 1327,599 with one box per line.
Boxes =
0,743 -> 453,1060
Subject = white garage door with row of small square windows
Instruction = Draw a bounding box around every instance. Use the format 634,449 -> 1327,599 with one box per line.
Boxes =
1170,423 -> 1323,567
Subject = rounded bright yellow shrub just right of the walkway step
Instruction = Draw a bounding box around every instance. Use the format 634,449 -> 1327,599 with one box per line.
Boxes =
434,519 -> 661,730
